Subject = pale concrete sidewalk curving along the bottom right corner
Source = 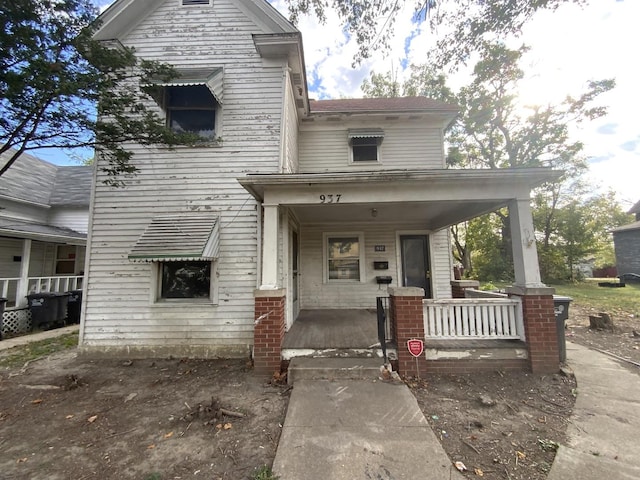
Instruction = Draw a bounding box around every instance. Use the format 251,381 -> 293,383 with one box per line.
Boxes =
547,342 -> 640,480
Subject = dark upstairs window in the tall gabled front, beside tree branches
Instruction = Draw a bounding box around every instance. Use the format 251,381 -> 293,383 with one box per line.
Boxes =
165,85 -> 218,138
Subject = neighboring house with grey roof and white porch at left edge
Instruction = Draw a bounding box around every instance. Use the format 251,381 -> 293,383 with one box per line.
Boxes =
0,151 -> 93,330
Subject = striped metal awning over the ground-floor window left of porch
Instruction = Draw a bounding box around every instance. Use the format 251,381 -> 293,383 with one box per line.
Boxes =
129,212 -> 220,262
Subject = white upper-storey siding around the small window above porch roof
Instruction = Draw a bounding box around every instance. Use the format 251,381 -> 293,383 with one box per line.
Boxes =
299,122 -> 445,173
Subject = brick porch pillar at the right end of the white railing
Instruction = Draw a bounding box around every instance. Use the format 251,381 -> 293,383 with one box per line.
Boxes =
507,286 -> 560,373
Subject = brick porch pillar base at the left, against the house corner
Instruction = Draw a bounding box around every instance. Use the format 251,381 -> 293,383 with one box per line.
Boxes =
253,288 -> 286,376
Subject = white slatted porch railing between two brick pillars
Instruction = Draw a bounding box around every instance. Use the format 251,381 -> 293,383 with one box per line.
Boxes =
423,298 -> 524,340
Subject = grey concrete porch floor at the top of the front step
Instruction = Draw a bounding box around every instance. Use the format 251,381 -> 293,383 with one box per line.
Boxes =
282,309 -> 378,349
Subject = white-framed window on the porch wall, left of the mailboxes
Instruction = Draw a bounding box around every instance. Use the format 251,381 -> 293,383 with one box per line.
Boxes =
324,233 -> 364,282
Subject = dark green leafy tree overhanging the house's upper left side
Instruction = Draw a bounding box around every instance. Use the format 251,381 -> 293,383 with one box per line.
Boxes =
0,0 -> 197,185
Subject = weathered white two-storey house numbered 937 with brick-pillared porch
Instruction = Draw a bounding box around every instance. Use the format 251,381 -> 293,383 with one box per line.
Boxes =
81,0 -> 558,374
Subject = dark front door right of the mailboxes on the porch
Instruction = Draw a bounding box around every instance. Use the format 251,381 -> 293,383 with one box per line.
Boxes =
400,235 -> 431,298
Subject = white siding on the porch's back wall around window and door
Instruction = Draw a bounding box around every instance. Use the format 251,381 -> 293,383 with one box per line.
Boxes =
300,224 -> 451,309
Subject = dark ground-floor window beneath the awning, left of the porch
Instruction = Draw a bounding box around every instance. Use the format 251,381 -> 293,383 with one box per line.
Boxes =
157,261 -> 213,300
